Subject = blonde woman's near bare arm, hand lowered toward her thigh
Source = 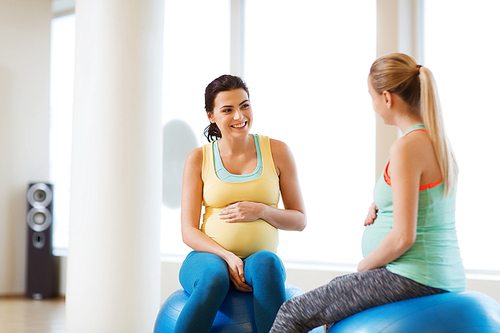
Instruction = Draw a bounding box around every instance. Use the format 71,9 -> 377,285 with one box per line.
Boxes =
358,140 -> 423,272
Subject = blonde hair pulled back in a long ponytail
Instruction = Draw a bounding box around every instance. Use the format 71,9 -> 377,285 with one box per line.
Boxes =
370,53 -> 458,195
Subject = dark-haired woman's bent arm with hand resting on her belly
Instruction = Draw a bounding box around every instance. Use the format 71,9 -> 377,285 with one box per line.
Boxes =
219,140 -> 307,231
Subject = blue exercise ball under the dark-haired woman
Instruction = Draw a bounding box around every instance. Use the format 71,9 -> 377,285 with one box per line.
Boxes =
154,284 -> 324,333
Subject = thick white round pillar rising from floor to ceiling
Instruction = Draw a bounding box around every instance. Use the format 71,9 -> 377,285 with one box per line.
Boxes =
66,0 -> 164,333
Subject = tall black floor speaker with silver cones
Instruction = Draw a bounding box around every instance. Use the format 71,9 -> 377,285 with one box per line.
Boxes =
26,183 -> 56,299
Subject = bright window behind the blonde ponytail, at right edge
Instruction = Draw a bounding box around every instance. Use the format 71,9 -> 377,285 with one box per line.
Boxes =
423,0 -> 500,272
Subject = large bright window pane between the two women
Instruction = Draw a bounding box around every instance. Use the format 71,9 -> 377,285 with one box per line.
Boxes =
244,0 -> 376,265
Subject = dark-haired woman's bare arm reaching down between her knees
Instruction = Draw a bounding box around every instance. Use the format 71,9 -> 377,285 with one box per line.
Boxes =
181,148 -> 252,291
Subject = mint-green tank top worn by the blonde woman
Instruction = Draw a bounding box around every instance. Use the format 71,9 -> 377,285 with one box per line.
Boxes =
362,125 -> 466,291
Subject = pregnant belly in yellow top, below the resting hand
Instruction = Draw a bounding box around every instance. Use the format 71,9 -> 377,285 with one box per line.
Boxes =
201,208 -> 279,258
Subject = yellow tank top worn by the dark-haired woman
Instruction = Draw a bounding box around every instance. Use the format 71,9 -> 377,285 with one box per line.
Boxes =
201,135 -> 280,258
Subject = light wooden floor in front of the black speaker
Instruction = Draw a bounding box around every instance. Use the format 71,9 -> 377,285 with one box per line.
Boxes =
0,296 -> 65,333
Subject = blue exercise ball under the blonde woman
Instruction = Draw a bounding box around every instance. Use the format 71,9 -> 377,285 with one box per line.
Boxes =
328,291 -> 500,333
